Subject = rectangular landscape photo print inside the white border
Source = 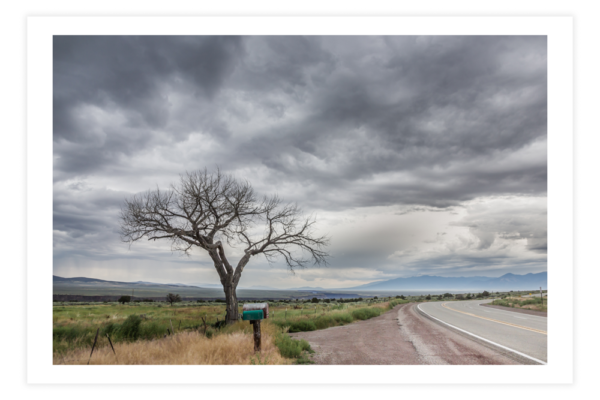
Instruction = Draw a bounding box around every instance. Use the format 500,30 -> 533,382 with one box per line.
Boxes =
52,35 -> 554,369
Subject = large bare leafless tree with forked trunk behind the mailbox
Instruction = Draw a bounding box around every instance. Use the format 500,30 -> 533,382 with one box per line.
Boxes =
121,169 -> 329,323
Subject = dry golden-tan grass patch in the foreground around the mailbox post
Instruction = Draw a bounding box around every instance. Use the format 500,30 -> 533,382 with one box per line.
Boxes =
54,327 -> 290,365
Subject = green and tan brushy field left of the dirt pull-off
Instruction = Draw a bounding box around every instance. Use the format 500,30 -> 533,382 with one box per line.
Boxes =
53,298 -> 409,365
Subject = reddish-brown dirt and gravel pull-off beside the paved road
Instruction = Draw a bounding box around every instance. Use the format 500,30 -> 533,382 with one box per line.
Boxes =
290,303 -> 519,365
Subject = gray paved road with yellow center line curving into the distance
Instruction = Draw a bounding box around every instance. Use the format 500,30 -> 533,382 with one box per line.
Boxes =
419,300 -> 548,362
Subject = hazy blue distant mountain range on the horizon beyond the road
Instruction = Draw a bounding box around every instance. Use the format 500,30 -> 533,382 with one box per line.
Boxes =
348,272 -> 548,291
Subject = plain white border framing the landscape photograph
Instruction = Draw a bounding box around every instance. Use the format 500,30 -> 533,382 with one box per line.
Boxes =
27,17 -> 573,384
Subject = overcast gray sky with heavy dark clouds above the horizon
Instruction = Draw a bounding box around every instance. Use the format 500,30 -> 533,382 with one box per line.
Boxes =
53,36 -> 547,288
